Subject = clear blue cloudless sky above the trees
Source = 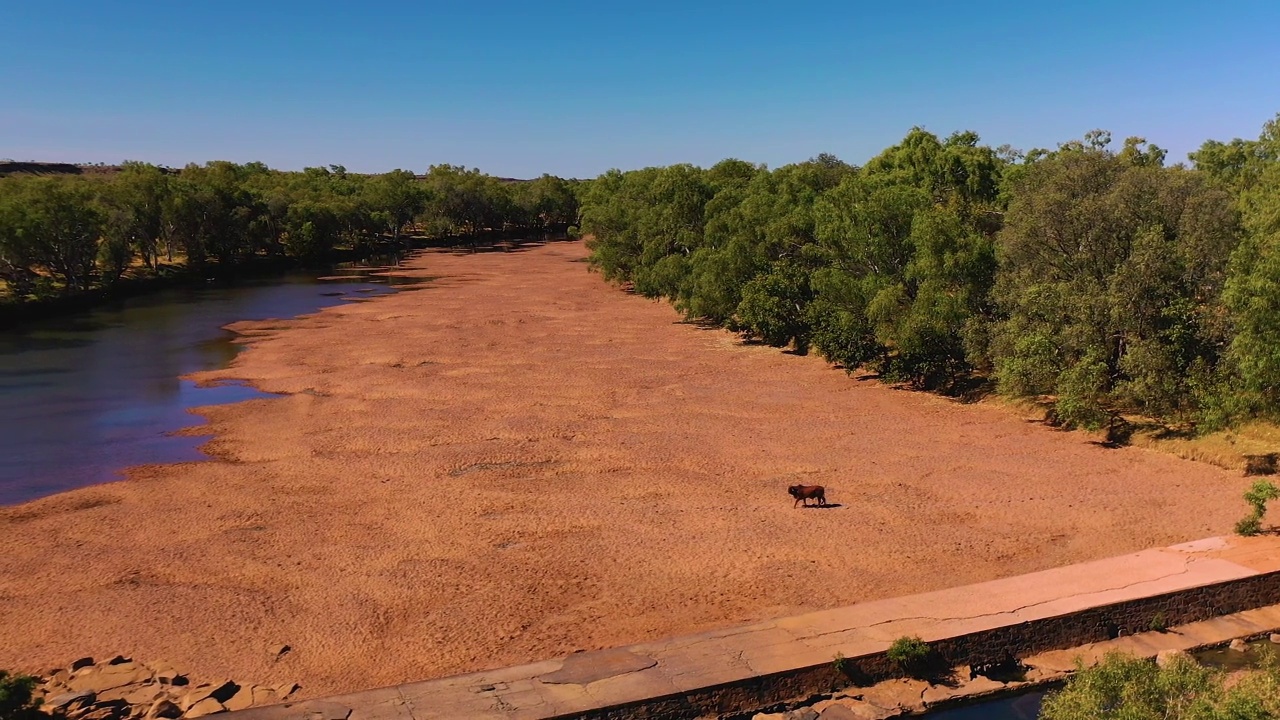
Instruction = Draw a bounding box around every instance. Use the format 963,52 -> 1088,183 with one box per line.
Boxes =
0,0 -> 1280,177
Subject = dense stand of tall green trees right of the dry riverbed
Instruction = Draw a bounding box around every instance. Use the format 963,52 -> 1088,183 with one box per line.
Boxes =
581,117 -> 1280,429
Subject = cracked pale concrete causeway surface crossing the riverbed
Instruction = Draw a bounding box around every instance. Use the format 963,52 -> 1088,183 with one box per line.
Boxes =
225,537 -> 1280,720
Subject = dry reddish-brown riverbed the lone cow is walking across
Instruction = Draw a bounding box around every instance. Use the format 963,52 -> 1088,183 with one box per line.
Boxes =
0,243 -> 1244,696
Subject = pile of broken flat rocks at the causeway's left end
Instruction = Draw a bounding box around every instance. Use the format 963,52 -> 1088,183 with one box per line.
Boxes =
38,656 -> 300,720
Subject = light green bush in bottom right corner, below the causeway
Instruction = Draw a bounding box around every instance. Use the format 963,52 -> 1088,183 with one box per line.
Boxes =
1041,655 -> 1280,720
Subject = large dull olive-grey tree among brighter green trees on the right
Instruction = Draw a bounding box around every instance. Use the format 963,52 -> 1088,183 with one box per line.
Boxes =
991,132 -> 1239,427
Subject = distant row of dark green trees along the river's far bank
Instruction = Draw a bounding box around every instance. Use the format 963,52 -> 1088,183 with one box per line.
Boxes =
0,161 -> 577,302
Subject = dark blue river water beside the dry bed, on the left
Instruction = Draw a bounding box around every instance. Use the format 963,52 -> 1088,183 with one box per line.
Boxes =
0,260 -> 417,505
